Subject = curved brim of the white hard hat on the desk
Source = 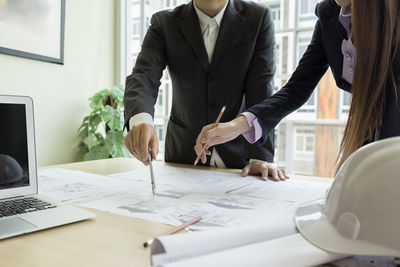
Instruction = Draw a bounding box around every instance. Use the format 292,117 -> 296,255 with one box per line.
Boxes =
295,200 -> 400,257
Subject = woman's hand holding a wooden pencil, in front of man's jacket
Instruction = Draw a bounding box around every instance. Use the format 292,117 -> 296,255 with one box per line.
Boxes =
194,116 -> 251,164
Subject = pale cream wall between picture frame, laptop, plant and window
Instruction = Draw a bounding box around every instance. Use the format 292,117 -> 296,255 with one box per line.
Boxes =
0,0 -> 115,166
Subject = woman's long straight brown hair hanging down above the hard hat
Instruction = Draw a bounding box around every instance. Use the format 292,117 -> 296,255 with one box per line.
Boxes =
337,0 -> 400,169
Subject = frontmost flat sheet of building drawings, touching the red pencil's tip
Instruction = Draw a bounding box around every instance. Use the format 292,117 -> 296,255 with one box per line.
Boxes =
79,192 -> 296,229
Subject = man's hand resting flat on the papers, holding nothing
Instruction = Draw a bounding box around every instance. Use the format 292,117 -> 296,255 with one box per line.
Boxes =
242,160 -> 289,182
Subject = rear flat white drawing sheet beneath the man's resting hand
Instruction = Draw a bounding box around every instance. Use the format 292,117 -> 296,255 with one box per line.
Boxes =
107,165 -> 332,203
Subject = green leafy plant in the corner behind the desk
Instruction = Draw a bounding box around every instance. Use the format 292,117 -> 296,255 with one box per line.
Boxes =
78,86 -> 130,161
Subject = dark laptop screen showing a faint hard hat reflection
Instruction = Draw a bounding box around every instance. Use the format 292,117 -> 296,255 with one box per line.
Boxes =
0,103 -> 29,190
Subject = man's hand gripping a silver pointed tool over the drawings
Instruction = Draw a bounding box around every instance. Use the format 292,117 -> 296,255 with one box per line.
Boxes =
124,123 -> 158,166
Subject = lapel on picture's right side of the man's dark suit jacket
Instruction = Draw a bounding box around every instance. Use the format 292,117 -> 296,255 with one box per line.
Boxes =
211,0 -> 245,71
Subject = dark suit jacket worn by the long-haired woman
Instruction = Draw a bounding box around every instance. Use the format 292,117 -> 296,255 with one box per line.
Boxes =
248,0 -> 400,144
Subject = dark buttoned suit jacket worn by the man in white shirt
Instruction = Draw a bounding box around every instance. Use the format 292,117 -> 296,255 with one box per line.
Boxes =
124,0 -> 275,168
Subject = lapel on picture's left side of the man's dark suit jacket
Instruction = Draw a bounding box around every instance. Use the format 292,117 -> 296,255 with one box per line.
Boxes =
178,2 -> 210,71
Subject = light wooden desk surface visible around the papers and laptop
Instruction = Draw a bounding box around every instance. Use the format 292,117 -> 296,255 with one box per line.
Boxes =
0,158 -> 327,267
